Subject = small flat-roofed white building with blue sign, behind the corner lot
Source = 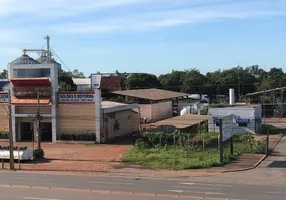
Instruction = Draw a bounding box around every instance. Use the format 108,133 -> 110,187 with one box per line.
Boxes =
208,105 -> 262,134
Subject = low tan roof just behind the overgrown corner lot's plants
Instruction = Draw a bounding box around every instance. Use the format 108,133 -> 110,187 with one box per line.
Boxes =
152,114 -> 213,129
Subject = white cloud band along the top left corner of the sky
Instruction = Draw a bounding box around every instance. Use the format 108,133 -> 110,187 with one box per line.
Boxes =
0,0 -> 152,18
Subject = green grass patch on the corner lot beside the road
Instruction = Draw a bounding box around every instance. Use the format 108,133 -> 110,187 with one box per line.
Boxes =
122,134 -> 264,170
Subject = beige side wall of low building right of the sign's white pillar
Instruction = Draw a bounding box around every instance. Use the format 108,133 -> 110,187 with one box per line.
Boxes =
105,109 -> 140,139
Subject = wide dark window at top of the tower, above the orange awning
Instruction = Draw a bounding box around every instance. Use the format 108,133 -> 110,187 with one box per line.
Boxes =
14,68 -> 51,78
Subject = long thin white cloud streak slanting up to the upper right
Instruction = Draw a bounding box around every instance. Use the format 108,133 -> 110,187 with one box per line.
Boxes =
50,0 -> 286,34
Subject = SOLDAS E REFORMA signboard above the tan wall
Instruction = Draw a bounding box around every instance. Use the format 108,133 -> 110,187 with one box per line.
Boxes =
58,92 -> 95,103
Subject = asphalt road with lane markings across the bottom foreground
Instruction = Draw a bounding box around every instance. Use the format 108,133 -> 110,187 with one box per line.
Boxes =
0,172 -> 286,200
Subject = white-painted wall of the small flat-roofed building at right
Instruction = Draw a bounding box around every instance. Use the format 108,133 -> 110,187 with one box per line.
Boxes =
208,106 -> 261,133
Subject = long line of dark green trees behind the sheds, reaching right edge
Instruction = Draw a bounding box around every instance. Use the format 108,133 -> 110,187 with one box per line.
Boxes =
117,65 -> 286,99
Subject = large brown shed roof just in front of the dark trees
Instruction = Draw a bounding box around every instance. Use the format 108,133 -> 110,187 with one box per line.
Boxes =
112,88 -> 189,101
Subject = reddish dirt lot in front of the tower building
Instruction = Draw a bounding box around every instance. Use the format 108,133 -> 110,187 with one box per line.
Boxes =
0,142 -> 130,172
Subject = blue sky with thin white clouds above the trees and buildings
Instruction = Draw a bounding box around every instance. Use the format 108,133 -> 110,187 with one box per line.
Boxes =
0,0 -> 286,75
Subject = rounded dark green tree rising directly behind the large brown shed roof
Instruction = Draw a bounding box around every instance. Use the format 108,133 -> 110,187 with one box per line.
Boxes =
126,73 -> 160,89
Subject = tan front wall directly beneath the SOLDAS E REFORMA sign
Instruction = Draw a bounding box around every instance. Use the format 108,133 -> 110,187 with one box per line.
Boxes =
57,103 -> 95,134
